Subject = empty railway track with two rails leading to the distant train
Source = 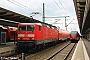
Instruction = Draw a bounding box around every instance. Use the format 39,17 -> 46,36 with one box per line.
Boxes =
46,43 -> 76,60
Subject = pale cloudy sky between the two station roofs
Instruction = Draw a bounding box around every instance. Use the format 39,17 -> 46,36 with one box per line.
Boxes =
0,0 -> 79,31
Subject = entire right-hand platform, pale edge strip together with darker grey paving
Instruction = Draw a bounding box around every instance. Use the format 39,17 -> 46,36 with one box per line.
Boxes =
71,38 -> 90,60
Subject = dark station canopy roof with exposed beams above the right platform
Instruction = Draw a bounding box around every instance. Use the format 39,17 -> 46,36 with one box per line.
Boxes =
73,0 -> 90,34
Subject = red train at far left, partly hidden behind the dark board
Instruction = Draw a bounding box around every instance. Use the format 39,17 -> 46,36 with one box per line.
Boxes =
0,26 -> 17,42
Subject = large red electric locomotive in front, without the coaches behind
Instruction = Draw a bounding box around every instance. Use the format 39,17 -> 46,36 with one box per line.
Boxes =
16,23 -> 58,48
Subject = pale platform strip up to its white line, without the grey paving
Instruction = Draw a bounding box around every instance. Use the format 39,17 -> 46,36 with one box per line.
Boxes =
71,38 -> 89,60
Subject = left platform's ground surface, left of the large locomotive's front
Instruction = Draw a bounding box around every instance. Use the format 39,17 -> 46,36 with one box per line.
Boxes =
0,42 -> 16,57
